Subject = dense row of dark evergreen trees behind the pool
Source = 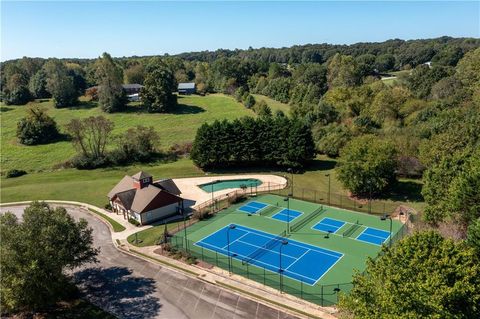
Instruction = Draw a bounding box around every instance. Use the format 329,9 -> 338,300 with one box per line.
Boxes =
191,116 -> 314,168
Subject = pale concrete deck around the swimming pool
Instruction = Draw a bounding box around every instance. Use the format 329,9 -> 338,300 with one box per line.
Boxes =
173,174 -> 287,208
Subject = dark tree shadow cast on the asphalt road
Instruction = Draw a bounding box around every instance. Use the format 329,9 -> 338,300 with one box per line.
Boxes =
74,267 -> 162,319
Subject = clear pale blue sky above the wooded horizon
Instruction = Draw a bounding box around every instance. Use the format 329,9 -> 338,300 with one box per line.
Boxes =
0,0 -> 480,61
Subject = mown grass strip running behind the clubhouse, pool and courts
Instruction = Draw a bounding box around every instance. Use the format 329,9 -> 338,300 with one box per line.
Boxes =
0,157 -> 424,210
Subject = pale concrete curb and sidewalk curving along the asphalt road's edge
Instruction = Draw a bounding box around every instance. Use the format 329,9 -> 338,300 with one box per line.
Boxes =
0,200 -> 335,318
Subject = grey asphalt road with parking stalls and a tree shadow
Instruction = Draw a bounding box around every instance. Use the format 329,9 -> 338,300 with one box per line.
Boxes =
0,206 -> 295,319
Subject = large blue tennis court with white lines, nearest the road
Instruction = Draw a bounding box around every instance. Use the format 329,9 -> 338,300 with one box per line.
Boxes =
195,225 -> 343,285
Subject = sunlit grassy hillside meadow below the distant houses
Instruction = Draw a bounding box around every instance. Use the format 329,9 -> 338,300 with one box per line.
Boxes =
0,94 -> 254,173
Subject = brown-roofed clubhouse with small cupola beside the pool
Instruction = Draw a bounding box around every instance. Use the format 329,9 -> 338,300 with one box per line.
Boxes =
107,171 -> 183,225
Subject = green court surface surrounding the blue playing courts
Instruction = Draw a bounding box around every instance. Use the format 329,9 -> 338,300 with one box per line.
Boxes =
172,195 -> 403,304
